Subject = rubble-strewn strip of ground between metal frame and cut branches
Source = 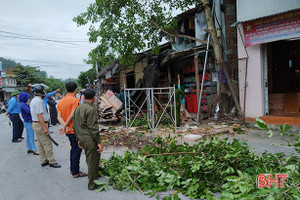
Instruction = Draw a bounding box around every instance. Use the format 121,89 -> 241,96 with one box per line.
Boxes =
100,117 -> 252,149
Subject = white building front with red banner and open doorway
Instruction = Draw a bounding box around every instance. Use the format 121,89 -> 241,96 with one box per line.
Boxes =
234,0 -> 300,125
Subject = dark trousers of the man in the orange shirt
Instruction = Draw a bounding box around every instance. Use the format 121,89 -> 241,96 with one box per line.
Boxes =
66,134 -> 82,175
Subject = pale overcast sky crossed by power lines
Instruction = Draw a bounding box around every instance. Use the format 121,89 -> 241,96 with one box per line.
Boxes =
0,0 -> 95,79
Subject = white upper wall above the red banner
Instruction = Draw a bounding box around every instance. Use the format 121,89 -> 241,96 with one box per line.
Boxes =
236,0 -> 300,22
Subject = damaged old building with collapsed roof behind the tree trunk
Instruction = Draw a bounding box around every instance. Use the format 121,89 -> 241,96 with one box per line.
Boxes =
99,0 -> 238,118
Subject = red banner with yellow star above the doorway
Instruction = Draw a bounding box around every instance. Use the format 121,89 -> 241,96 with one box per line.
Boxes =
243,9 -> 300,47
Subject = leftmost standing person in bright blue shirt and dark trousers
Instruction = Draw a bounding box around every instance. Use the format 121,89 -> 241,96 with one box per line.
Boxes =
7,90 -> 24,143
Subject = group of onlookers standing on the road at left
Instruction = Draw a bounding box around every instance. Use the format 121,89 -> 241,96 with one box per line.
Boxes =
7,82 -> 104,190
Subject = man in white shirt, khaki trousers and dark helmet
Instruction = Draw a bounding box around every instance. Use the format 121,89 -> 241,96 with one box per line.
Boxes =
30,84 -> 61,168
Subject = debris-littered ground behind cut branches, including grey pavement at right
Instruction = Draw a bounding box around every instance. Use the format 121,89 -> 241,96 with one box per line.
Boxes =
100,115 -> 300,158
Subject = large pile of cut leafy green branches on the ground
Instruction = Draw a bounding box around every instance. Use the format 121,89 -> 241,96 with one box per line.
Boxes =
96,132 -> 300,200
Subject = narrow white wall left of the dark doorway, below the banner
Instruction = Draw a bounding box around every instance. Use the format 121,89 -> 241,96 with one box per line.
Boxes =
238,25 -> 264,118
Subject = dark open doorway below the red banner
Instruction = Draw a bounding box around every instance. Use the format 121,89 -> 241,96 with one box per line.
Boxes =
267,39 -> 300,116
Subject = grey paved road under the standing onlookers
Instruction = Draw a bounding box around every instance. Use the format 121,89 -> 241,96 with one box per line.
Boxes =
0,114 -> 166,200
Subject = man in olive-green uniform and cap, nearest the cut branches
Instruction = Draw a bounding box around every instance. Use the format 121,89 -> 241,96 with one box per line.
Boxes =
73,89 -> 104,190
